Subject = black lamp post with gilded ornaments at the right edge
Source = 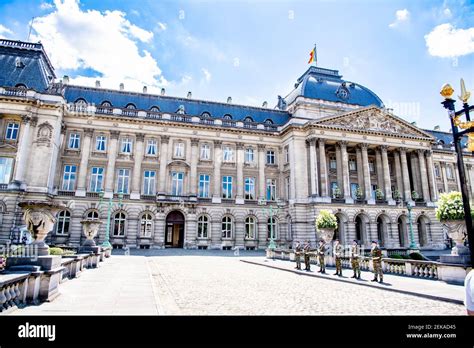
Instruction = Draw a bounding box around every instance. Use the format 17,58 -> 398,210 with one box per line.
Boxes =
440,79 -> 474,265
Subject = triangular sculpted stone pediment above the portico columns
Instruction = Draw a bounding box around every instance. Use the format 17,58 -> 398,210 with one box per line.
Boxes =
313,106 -> 434,139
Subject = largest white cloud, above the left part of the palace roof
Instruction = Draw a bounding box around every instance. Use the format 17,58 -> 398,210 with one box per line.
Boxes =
32,0 -> 167,90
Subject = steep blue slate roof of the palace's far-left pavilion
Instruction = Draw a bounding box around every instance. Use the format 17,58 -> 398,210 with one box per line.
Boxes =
0,39 -> 56,92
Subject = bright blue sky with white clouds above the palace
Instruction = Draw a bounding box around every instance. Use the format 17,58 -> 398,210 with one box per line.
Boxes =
0,0 -> 474,130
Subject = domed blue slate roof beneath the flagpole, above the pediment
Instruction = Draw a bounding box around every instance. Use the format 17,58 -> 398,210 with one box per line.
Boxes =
285,66 -> 383,107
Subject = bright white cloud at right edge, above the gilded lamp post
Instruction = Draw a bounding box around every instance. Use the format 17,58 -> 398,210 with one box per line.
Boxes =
425,23 -> 474,58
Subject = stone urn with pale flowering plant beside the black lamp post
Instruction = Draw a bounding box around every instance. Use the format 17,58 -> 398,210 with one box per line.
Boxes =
436,191 -> 472,255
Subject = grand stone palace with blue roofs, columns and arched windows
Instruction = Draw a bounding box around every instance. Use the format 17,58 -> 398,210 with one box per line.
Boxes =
0,40 -> 474,249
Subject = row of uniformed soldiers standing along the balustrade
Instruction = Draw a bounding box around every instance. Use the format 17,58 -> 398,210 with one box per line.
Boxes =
295,239 -> 383,283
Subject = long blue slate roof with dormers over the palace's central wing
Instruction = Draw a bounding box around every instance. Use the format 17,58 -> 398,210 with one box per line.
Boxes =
63,85 -> 290,125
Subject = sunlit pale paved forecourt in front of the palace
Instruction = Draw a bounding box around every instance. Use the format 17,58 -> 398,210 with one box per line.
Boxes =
12,250 -> 465,315
